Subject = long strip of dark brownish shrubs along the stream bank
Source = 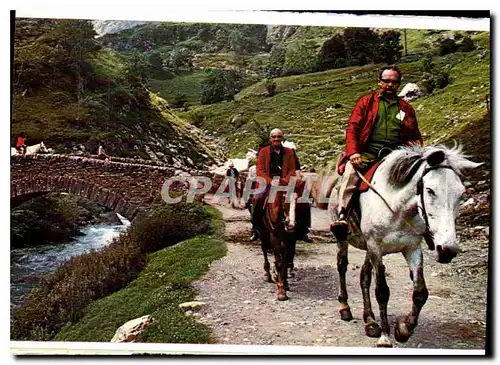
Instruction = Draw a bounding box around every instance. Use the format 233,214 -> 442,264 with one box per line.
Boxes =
11,202 -> 215,341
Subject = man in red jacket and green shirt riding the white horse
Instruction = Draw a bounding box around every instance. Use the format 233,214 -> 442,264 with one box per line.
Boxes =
330,66 -> 423,237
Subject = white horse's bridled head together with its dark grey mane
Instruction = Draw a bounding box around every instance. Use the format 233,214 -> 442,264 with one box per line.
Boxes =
390,145 -> 482,263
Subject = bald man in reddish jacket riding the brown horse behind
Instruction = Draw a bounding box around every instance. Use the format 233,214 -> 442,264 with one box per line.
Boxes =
251,128 -> 295,240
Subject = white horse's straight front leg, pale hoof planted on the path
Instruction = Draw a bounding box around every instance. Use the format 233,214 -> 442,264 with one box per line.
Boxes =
367,250 -> 392,347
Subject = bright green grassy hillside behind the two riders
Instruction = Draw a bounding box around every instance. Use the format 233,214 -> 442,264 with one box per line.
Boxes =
178,50 -> 490,167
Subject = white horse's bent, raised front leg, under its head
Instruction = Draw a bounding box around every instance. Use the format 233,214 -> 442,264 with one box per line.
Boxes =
394,246 -> 429,342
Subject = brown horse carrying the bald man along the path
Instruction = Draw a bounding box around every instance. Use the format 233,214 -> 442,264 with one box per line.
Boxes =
255,181 -> 304,300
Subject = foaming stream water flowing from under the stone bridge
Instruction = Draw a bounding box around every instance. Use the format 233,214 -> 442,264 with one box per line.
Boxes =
10,215 -> 130,309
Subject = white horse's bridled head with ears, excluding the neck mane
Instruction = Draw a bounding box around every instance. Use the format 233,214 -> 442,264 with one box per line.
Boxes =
417,147 -> 481,263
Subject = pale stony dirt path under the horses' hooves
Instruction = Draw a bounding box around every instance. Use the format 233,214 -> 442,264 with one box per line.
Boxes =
195,195 -> 488,349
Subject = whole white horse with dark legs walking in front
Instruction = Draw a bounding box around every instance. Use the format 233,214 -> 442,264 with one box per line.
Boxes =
316,146 -> 482,347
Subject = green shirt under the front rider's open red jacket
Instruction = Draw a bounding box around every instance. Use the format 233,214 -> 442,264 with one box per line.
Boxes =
362,96 -> 401,162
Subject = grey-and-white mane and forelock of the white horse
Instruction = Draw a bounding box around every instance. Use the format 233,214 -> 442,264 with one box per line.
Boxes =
387,143 -> 471,185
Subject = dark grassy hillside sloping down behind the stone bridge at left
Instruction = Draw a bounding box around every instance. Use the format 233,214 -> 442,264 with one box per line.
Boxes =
11,19 -> 221,168
